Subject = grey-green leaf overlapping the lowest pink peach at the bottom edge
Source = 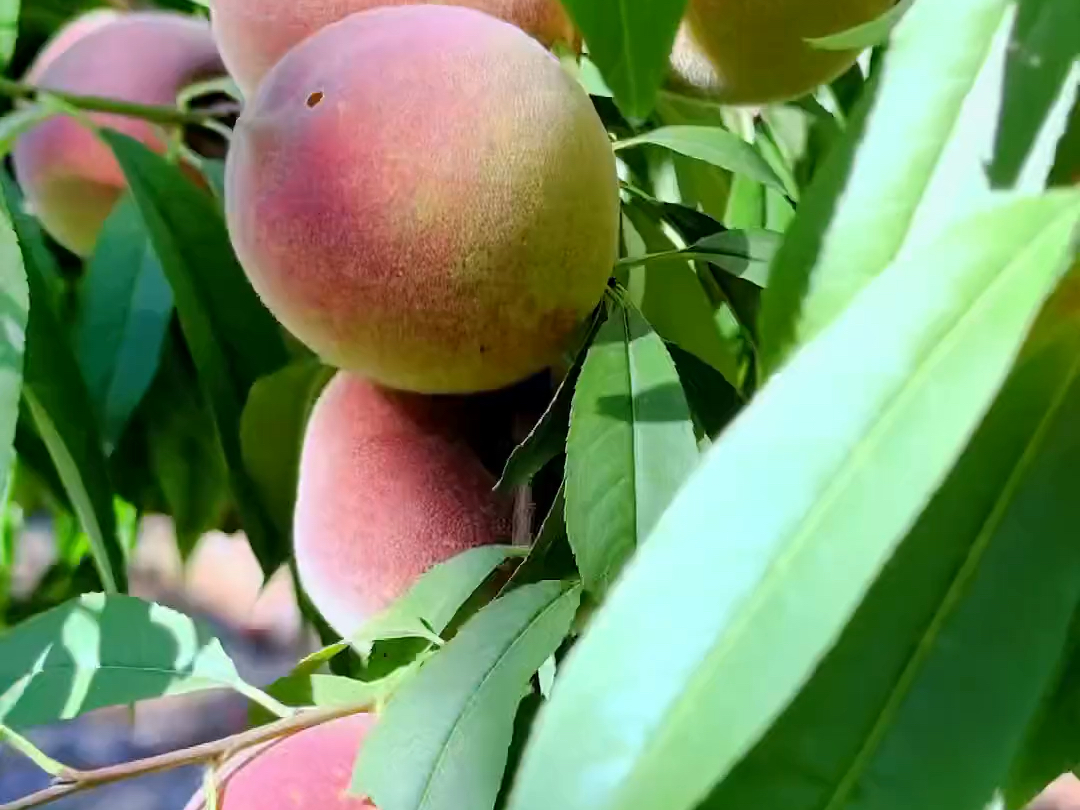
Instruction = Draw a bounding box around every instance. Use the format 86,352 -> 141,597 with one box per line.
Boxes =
352,582 -> 580,810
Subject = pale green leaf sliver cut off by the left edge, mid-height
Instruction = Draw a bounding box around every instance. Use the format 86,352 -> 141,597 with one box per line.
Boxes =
0,174 -> 30,505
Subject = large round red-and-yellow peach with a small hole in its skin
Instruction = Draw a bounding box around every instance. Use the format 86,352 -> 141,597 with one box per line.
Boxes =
226,5 -> 619,393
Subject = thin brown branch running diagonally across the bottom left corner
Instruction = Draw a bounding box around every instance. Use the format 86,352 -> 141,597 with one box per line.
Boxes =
0,703 -> 370,810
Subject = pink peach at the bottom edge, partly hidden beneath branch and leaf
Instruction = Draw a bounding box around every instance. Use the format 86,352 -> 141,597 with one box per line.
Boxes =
187,714 -> 375,810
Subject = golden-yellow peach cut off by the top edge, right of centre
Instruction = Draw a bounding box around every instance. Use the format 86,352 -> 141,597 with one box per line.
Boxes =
672,0 -> 894,105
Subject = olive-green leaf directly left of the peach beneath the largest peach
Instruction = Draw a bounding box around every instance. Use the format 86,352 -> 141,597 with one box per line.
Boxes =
240,360 -> 334,537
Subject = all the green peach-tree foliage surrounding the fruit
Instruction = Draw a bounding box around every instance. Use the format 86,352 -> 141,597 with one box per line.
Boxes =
0,0 -> 1080,810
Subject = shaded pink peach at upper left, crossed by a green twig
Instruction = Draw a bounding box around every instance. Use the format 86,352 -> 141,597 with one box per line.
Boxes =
13,12 -> 225,256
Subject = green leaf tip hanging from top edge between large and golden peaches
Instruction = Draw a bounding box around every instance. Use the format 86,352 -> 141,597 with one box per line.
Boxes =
563,0 -> 687,118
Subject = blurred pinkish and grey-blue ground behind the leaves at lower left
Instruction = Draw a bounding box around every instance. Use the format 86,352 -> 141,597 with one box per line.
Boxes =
0,516 -> 318,810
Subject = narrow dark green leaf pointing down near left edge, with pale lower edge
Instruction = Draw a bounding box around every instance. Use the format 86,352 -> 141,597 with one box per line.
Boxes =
0,173 -> 127,592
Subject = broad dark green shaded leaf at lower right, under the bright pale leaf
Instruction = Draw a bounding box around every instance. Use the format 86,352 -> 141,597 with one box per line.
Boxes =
702,278 -> 1080,810
